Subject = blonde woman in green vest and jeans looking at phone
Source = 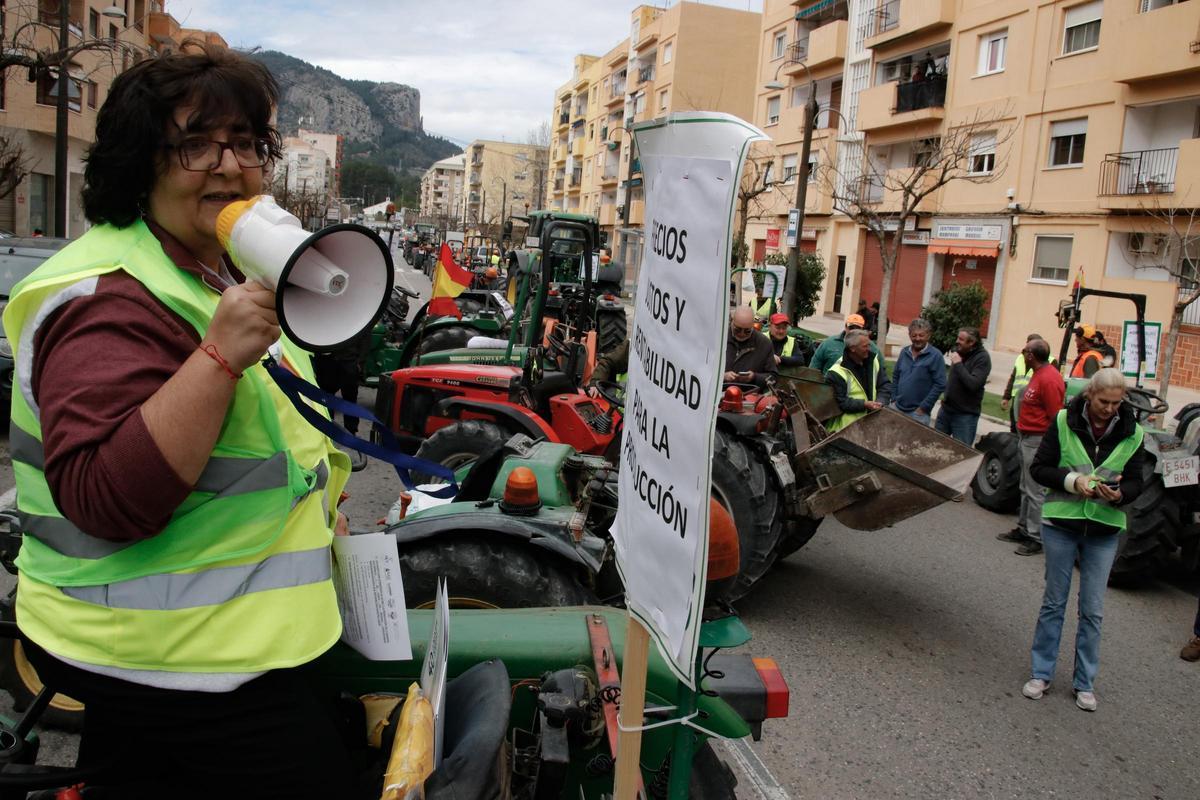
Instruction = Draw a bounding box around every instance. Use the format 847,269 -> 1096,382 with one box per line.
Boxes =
1021,367 -> 1146,711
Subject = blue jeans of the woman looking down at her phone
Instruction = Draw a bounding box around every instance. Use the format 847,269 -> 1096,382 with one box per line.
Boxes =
1031,521 -> 1121,692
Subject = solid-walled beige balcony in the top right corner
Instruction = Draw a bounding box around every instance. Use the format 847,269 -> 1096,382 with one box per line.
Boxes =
1105,2 -> 1200,84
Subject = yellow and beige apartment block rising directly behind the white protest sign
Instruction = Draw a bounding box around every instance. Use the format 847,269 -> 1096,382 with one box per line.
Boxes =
546,2 -> 761,279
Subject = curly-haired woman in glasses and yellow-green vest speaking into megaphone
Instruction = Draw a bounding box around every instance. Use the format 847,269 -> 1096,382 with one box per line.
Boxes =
4,47 -> 355,798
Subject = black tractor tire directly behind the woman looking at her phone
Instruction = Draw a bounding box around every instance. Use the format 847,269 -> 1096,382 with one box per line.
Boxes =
1109,457 -> 1182,587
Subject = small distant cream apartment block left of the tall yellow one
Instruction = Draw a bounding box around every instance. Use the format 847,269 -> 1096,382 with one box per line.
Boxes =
461,139 -> 547,225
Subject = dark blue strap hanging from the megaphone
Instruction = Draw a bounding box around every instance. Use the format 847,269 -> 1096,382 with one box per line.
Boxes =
263,356 -> 458,498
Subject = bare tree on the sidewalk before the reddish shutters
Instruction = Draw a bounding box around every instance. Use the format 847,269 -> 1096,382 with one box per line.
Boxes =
817,109 -> 1015,344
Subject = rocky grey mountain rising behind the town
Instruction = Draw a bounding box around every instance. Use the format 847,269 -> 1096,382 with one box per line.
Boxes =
251,50 -> 462,184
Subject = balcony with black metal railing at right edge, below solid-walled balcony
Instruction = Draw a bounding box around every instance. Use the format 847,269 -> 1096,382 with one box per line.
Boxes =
1097,139 -> 1200,210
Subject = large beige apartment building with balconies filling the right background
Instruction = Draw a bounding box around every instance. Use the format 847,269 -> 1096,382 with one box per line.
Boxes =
748,0 -> 1200,385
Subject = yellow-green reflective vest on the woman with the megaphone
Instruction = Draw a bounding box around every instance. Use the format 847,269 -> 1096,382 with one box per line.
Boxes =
4,222 -> 349,673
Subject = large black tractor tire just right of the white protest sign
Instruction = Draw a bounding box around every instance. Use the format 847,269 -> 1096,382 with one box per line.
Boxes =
713,429 -> 782,600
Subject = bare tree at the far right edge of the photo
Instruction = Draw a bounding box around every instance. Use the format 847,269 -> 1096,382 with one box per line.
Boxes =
1117,201 -> 1200,399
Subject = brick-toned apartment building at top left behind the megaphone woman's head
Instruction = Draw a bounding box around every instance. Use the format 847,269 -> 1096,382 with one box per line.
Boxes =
0,0 -> 224,237
